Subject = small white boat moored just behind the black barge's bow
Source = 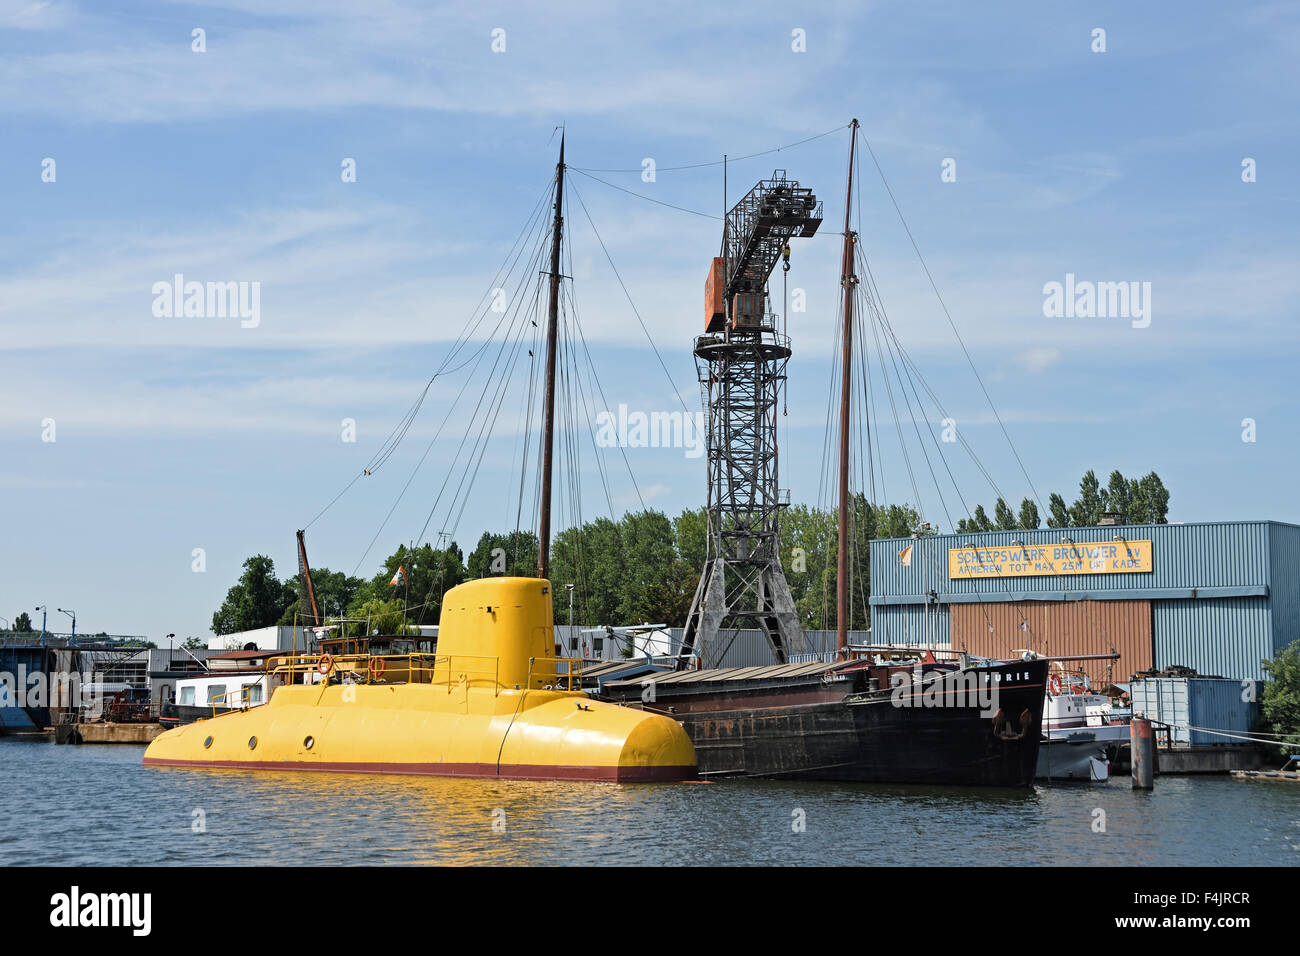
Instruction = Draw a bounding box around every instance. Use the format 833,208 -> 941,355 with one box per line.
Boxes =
1035,663 -> 1128,783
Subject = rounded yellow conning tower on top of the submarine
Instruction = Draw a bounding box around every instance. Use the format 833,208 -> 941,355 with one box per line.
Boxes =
436,578 -> 558,689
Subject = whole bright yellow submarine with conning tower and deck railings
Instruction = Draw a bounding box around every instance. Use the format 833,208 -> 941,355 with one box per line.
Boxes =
144,578 -> 697,783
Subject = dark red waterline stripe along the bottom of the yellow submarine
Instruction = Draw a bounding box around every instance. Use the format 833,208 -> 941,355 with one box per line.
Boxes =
144,757 -> 697,783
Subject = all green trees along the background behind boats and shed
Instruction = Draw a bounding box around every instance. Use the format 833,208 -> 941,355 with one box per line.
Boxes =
212,471 -> 1169,635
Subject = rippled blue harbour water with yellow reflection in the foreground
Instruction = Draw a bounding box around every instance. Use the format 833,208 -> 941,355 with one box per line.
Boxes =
0,739 -> 1300,866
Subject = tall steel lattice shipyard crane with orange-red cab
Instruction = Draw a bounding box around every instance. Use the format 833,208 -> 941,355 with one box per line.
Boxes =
679,169 -> 822,666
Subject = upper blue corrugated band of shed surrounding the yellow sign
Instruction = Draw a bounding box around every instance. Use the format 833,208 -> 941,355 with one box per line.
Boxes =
871,522 -> 1274,600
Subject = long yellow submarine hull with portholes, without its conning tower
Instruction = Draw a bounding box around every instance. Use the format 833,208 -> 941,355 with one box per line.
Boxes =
144,684 -> 696,783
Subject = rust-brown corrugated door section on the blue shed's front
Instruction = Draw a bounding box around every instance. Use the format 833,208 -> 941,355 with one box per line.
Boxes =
949,601 -> 1152,685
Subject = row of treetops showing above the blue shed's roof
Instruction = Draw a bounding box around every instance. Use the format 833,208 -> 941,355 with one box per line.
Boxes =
957,468 -> 1169,533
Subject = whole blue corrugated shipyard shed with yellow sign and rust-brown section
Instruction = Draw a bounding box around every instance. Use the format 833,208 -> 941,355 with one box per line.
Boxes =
871,522 -> 1300,682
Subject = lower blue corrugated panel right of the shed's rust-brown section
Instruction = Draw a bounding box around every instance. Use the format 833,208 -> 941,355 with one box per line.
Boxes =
1151,597 -> 1273,680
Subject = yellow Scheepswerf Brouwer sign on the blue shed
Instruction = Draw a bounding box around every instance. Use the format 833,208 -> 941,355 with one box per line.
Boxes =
948,541 -> 1151,579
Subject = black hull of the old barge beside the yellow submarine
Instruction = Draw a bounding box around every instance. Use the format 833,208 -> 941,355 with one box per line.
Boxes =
602,659 -> 1048,787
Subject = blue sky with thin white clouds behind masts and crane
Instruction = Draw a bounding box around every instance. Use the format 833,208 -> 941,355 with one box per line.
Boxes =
0,0 -> 1300,641
